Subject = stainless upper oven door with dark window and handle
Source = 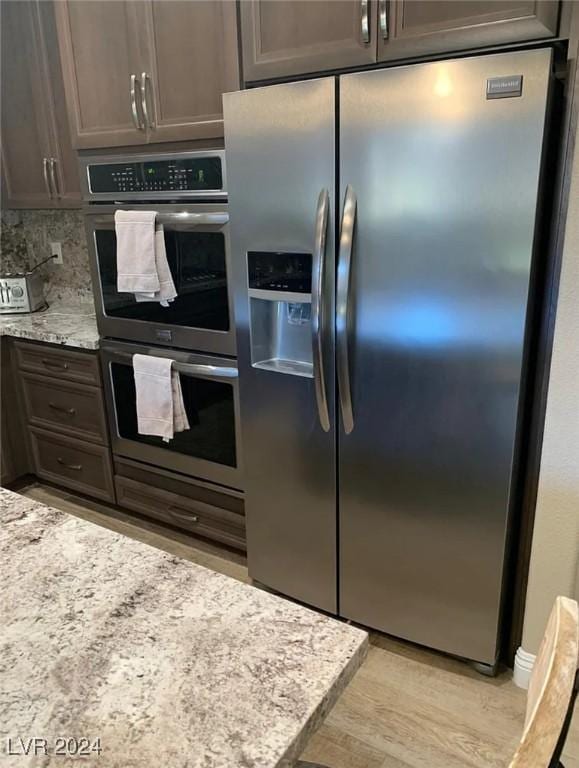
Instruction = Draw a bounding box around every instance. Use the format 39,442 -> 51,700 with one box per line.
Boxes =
86,203 -> 236,356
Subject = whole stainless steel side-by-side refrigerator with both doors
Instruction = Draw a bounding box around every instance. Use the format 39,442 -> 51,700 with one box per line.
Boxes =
224,49 -> 551,668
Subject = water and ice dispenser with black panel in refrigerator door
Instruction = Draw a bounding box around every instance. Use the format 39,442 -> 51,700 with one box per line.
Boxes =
247,251 -> 313,377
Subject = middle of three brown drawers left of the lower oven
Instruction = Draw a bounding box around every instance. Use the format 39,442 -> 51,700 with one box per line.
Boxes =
20,373 -> 108,444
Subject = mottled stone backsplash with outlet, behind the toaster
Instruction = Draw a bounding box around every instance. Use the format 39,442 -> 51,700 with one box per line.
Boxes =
0,210 -> 92,303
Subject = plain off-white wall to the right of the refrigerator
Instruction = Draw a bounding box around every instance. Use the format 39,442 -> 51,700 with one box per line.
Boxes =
522,124 -> 579,654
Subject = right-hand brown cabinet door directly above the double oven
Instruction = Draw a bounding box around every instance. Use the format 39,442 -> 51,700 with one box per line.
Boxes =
139,0 -> 239,142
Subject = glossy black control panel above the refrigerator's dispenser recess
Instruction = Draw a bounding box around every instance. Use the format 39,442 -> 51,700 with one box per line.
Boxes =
247,251 -> 312,293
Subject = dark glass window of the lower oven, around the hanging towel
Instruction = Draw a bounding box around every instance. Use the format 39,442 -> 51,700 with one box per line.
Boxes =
111,363 -> 237,467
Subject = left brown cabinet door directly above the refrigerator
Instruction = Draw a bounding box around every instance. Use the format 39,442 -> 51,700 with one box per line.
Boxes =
240,0 -> 376,81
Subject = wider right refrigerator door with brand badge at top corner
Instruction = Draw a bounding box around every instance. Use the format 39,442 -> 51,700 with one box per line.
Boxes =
338,50 -> 551,664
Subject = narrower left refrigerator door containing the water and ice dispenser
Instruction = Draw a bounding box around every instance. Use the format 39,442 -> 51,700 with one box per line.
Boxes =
224,78 -> 337,612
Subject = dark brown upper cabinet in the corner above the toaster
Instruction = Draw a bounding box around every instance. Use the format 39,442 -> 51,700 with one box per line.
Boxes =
0,0 -> 80,208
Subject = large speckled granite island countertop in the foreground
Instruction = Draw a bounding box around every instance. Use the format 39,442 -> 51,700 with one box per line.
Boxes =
0,490 -> 368,768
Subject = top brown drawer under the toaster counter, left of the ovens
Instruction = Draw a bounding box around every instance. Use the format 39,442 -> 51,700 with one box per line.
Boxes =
14,341 -> 101,387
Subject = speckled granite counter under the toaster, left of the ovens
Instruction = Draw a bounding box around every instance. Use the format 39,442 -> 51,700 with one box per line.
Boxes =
0,300 -> 99,349
